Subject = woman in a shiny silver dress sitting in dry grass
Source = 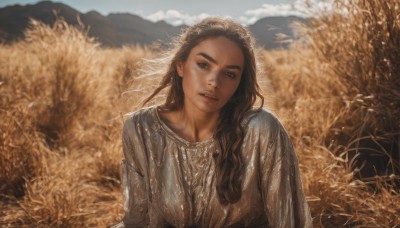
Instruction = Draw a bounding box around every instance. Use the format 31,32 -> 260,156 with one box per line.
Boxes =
114,18 -> 312,227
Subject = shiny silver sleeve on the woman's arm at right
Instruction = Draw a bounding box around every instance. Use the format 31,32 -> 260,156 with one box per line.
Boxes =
261,118 -> 312,227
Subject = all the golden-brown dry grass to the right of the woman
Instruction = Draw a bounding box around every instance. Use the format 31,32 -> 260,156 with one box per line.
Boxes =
265,1 -> 400,227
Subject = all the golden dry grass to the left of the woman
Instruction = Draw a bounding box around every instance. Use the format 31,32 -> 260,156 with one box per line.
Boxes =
0,19 -> 147,227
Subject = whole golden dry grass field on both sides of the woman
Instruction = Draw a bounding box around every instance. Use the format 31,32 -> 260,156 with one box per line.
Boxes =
0,0 -> 400,227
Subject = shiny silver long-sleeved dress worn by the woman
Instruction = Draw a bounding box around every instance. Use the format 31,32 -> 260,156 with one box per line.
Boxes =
115,106 -> 312,228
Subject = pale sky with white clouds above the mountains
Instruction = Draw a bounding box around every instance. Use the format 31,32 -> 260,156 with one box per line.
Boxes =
0,0 -> 329,25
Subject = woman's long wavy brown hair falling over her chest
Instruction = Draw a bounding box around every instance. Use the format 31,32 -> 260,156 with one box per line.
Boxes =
144,17 -> 264,204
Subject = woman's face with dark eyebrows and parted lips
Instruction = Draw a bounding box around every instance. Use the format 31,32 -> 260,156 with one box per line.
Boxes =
177,36 -> 244,116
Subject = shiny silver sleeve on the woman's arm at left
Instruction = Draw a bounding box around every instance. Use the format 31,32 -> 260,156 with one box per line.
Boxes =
121,116 -> 149,227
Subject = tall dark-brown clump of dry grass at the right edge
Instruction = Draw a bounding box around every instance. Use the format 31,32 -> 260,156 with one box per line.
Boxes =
307,0 -> 400,182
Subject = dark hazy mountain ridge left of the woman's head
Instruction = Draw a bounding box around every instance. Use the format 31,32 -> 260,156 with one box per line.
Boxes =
0,1 -> 183,47
